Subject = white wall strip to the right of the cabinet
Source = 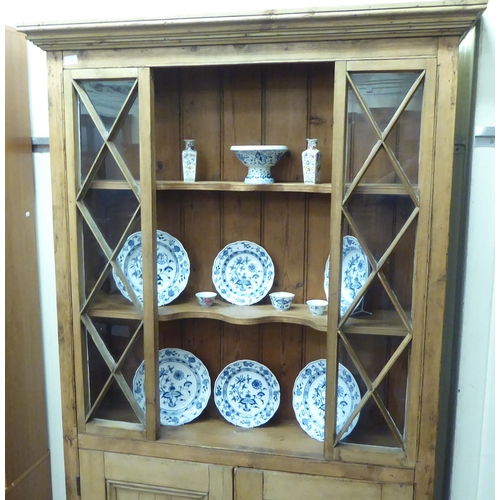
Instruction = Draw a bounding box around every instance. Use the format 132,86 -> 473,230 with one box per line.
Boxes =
450,0 -> 500,500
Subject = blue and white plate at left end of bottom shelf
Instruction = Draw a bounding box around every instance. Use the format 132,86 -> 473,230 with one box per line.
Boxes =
133,349 -> 211,425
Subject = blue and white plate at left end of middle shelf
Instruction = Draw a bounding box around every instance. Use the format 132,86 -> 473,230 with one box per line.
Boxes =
113,231 -> 190,306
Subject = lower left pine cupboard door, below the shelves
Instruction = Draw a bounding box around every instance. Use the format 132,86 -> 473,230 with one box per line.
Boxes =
80,450 -> 233,500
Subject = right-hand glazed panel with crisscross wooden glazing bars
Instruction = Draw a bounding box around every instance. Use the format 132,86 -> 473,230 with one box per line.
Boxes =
326,59 -> 435,465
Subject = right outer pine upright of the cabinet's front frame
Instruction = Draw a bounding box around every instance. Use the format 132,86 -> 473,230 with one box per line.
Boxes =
415,38 -> 458,499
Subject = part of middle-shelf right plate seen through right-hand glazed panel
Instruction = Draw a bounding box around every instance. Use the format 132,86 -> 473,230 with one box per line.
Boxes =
340,236 -> 370,316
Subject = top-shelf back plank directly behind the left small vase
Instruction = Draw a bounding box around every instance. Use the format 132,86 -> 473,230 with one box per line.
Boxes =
181,67 -> 221,181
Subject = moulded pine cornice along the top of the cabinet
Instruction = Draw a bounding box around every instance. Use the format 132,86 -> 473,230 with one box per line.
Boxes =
18,0 -> 487,50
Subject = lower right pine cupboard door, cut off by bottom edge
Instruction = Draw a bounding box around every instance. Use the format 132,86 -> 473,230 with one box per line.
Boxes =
235,468 -> 413,500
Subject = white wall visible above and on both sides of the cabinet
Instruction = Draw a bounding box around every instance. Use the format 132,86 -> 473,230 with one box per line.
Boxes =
4,0 -> 498,500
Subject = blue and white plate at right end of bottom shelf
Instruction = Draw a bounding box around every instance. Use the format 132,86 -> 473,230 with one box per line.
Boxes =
292,359 -> 361,441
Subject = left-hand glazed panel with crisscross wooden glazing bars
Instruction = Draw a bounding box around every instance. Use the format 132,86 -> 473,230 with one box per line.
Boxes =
65,68 -> 157,437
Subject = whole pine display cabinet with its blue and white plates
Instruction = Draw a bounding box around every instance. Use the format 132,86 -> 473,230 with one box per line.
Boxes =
18,0 -> 486,500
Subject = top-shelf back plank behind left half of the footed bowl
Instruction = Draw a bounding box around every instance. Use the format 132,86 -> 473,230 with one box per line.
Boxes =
222,65 -> 262,181
